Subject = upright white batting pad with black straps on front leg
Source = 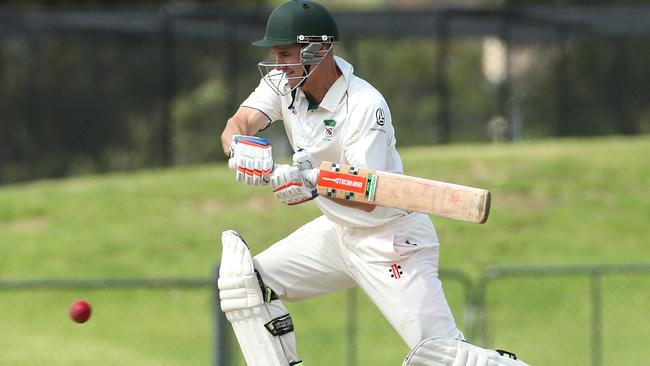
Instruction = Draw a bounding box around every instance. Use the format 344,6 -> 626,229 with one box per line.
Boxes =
218,230 -> 290,366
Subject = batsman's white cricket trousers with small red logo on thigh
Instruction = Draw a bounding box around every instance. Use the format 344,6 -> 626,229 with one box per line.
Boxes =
254,214 -> 463,348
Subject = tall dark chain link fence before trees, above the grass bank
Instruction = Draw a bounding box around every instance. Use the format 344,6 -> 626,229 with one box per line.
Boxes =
0,4 -> 650,183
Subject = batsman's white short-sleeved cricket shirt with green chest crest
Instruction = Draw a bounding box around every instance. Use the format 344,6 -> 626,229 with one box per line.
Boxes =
241,56 -> 407,227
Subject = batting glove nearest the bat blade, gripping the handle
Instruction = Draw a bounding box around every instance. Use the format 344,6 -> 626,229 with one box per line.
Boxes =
271,164 -> 316,205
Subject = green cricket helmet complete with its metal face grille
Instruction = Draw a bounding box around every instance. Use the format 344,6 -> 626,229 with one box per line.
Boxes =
253,0 -> 339,95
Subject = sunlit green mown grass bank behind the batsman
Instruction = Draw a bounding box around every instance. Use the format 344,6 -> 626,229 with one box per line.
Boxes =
0,137 -> 650,365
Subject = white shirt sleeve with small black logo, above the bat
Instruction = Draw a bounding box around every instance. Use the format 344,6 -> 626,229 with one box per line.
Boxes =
344,95 -> 395,171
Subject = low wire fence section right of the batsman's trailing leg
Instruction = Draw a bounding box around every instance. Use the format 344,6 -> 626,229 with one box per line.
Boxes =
477,264 -> 650,366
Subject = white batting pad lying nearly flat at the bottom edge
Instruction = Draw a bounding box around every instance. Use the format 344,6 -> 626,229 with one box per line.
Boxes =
402,337 -> 528,366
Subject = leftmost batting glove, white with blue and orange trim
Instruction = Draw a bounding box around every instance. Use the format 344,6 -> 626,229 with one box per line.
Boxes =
228,135 -> 273,186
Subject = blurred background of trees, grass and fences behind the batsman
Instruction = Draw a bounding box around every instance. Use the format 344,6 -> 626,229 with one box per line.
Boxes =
0,0 -> 650,365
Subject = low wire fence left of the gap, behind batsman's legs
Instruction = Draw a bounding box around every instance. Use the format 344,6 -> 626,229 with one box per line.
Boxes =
0,271 -> 470,366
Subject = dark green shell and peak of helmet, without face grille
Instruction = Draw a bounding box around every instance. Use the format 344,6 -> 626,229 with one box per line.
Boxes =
253,0 -> 339,47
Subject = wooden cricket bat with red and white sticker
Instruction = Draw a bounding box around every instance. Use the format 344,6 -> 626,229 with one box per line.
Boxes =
316,161 -> 490,224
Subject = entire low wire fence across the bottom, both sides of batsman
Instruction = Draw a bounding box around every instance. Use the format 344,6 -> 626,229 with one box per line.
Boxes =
0,264 -> 650,366
